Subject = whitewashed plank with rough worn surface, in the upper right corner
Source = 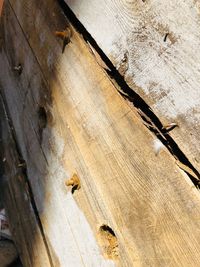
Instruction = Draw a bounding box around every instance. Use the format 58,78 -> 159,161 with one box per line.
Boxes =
65,0 -> 200,172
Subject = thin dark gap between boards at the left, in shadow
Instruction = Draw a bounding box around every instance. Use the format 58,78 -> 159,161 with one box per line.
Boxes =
0,92 -> 53,267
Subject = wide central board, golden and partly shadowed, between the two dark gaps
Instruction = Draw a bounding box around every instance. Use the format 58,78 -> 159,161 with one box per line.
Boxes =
0,0 -> 200,267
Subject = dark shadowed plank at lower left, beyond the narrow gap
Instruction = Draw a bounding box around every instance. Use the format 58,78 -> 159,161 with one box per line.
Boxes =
0,97 -> 51,267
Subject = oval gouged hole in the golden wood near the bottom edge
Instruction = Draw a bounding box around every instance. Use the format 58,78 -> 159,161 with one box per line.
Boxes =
99,224 -> 119,259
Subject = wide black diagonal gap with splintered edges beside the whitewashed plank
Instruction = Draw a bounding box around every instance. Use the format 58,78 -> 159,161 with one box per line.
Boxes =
58,0 -> 200,188
